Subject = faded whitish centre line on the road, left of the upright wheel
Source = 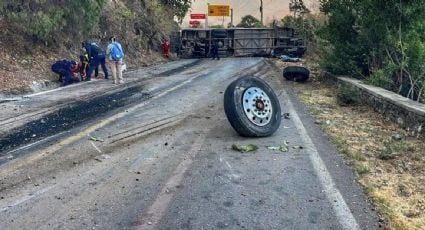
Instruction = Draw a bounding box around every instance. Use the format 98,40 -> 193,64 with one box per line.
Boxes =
135,134 -> 206,230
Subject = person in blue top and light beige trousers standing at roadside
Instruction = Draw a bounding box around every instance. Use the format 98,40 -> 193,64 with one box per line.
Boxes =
106,37 -> 124,84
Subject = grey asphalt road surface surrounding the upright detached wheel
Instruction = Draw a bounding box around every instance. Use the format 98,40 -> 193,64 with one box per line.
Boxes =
0,58 -> 379,230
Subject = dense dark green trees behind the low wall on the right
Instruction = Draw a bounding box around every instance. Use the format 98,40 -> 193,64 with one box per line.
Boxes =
320,0 -> 425,100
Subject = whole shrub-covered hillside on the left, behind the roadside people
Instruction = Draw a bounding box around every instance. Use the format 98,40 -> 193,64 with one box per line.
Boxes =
0,0 -> 178,95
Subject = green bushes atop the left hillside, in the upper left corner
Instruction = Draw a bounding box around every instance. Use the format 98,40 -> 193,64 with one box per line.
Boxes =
0,0 -> 106,42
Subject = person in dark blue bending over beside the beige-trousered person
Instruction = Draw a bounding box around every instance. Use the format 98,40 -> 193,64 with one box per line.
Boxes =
82,41 -> 108,81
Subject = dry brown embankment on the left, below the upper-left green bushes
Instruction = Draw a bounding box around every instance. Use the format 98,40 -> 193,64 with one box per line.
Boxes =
0,0 -> 178,95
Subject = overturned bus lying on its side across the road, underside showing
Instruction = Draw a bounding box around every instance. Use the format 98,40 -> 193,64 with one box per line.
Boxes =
171,27 -> 306,58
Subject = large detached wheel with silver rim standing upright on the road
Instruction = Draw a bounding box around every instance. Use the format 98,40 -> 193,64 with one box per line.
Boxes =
224,77 -> 281,137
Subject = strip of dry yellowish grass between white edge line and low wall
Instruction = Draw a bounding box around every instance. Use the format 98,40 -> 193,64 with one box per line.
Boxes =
276,60 -> 425,229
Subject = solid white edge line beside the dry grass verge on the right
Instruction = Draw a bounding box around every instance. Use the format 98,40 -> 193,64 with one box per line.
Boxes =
282,90 -> 360,230
